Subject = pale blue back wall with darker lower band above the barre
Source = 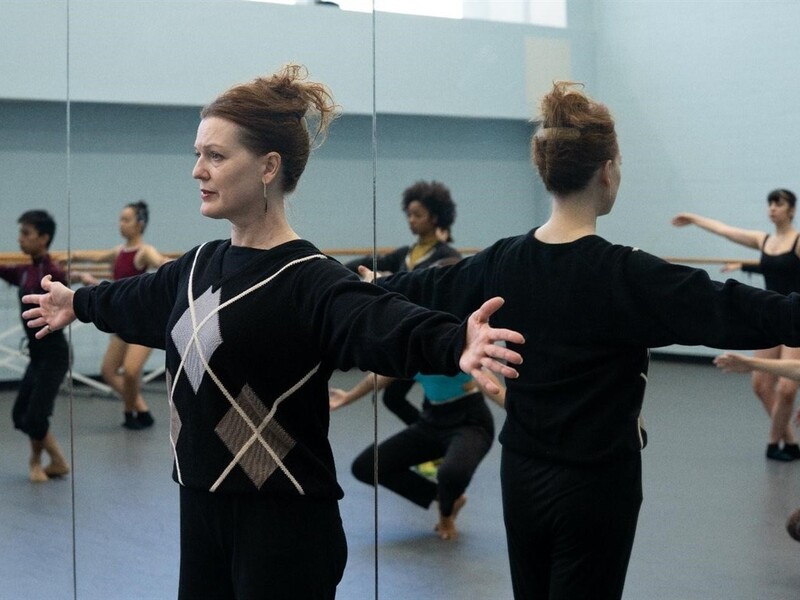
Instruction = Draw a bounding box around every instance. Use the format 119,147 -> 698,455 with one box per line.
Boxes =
0,0 -> 576,378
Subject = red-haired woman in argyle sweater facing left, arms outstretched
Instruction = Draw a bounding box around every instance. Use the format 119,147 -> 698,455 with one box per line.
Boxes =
20,65 -> 524,600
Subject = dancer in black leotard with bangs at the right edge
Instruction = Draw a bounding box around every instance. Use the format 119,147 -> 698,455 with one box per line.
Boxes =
672,189 -> 800,462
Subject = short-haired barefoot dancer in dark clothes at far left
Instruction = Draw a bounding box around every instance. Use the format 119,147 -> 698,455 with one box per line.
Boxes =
0,210 -> 69,482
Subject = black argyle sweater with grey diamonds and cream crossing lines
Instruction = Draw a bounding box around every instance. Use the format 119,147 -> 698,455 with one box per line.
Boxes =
74,240 -> 465,498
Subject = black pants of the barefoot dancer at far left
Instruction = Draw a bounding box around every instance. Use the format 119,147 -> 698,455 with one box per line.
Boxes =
11,332 -> 69,441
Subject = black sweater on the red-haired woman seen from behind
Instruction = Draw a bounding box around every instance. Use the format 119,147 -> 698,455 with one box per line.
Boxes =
379,232 -> 800,463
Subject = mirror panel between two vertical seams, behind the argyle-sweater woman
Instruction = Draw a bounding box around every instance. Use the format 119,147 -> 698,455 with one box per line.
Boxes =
62,0 -> 372,598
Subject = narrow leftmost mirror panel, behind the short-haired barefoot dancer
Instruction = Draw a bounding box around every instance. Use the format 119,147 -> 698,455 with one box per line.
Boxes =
0,2 -> 73,598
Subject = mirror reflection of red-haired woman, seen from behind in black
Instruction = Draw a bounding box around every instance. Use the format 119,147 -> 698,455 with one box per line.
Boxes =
364,82 -> 800,600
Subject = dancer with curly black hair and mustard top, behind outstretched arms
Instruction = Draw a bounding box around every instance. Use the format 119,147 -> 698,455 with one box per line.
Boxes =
346,181 -> 461,425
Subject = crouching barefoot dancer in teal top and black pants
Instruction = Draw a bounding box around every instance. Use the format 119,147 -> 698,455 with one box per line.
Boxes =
330,373 -> 505,540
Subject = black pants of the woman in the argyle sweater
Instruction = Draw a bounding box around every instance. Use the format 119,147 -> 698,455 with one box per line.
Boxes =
178,486 -> 347,600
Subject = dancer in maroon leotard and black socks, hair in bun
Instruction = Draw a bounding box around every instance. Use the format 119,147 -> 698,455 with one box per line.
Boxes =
72,200 -> 170,431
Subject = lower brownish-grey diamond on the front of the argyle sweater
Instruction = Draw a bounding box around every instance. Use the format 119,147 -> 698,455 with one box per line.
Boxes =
215,385 -> 295,488
